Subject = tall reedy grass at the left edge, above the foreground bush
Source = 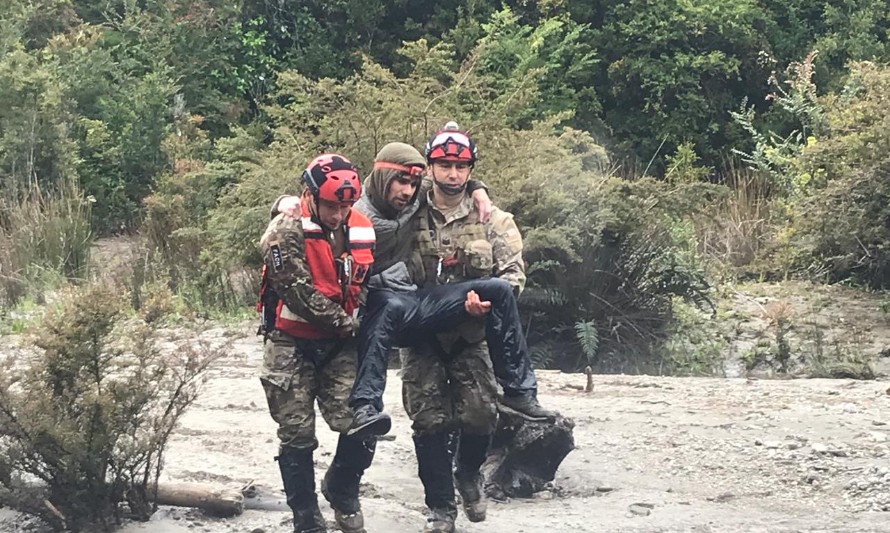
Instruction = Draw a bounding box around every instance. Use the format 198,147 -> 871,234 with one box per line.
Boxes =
0,181 -> 93,305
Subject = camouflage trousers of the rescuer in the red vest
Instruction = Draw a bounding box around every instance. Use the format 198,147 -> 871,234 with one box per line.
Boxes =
260,331 -> 356,451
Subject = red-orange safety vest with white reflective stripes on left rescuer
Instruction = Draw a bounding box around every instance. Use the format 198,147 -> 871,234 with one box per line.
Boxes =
257,201 -> 375,339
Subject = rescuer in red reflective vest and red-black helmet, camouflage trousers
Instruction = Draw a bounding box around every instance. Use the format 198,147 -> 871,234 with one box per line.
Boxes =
260,154 -> 376,533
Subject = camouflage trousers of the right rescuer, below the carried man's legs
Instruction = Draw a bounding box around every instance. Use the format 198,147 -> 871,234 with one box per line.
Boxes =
400,340 -> 498,435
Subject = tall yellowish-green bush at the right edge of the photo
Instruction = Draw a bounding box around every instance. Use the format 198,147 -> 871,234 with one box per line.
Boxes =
793,63 -> 890,289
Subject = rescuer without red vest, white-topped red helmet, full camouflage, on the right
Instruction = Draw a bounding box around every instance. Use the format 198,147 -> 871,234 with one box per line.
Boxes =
400,125 -> 526,533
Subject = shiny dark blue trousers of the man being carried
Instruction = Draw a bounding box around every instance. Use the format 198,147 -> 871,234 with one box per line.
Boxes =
349,278 -> 537,410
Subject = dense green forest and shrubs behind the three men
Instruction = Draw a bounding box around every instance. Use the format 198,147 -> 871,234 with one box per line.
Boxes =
0,0 -> 890,374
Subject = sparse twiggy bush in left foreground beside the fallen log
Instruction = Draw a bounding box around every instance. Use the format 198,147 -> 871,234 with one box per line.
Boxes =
0,286 -> 218,531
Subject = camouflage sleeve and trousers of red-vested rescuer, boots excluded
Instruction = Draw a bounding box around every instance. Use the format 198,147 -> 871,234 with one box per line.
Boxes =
260,209 -> 356,449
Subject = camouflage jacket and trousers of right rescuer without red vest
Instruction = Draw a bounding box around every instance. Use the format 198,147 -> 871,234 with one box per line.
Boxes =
401,193 -> 526,435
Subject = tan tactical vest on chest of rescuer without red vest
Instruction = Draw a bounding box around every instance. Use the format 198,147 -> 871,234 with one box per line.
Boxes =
415,200 -> 494,287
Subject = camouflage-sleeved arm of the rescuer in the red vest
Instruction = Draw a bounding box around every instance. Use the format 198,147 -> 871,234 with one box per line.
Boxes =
260,215 -> 351,328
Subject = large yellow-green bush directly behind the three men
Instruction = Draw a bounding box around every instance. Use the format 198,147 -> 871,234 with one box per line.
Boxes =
187,35 -> 717,370
